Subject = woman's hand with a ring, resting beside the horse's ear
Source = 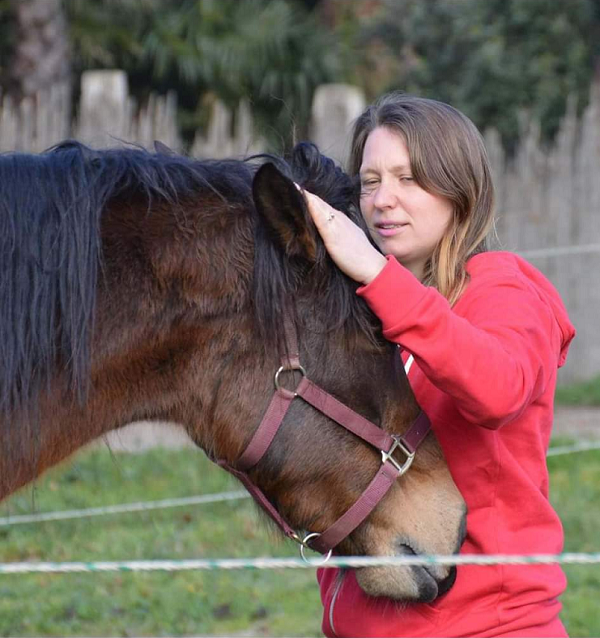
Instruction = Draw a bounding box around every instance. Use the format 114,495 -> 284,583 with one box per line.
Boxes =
298,187 -> 387,285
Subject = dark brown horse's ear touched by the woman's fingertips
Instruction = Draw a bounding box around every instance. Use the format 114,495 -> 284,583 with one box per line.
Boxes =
252,162 -> 317,262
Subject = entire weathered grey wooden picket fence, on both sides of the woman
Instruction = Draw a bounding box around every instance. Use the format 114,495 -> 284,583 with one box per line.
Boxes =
0,71 -> 600,383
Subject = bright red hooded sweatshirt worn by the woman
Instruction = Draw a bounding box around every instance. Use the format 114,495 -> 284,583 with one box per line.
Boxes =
318,252 -> 575,638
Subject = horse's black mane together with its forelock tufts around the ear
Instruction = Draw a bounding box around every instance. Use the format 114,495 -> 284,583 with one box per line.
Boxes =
0,141 -> 376,414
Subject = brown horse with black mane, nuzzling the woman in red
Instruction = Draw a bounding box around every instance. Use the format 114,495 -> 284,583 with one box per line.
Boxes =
0,140 -> 465,601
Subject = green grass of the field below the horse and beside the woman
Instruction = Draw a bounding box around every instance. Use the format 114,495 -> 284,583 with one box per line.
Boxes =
0,441 -> 600,636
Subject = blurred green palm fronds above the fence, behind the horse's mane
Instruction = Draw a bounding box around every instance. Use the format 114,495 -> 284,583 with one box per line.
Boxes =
67,0 -> 337,150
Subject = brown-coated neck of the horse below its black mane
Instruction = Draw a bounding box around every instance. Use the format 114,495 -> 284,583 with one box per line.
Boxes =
0,201 -> 252,498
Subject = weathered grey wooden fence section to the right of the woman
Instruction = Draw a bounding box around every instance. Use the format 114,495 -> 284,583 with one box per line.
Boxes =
486,84 -> 600,383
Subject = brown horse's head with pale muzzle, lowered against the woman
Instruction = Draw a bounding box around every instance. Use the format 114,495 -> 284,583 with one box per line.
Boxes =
196,145 -> 465,600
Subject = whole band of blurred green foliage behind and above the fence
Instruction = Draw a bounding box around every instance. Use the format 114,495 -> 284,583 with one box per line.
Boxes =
0,0 -> 600,150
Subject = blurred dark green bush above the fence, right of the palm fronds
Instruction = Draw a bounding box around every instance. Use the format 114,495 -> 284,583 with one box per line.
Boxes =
352,0 -> 600,149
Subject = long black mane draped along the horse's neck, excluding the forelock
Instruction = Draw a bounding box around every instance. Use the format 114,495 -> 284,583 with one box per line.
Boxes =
0,141 -> 252,413
